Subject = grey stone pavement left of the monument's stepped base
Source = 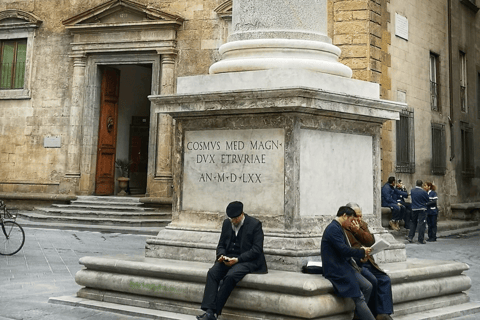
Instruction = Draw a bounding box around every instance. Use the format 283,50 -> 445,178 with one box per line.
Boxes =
0,228 -> 146,320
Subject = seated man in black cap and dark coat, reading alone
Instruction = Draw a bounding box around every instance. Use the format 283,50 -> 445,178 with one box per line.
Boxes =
197,201 -> 267,320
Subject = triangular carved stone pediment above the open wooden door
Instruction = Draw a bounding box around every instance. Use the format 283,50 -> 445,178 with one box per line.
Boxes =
63,0 -> 183,29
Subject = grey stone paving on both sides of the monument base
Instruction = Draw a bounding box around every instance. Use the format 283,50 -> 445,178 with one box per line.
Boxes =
0,228 -> 480,320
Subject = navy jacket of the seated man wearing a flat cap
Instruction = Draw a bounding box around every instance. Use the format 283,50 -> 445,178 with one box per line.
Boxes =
217,214 -> 268,273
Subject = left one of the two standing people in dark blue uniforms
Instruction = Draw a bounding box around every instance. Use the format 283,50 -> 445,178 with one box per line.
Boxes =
407,180 -> 429,244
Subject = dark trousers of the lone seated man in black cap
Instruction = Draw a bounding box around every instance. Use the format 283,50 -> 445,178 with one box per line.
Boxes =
201,262 -> 251,315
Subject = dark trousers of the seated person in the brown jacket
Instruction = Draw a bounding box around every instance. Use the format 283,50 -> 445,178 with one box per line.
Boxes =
362,261 -> 393,317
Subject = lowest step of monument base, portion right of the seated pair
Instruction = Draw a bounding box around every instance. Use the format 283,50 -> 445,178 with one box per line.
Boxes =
392,302 -> 480,320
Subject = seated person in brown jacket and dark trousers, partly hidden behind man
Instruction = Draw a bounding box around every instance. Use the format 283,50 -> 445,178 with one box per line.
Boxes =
343,202 -> 393,320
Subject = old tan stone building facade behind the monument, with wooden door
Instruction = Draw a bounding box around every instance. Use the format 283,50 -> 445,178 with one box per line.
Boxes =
0,0 -> 480,217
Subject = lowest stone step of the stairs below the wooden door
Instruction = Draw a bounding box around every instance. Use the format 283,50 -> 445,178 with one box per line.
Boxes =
16,211 -> 171,227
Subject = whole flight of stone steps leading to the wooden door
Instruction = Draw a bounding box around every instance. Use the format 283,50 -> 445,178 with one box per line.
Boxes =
16,196 -> 172,235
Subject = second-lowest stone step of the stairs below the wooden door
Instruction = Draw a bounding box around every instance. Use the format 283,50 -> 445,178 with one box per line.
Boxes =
32,208 -> 172,219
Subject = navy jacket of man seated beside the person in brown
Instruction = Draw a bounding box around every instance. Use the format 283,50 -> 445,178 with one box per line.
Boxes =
320,220 -> 365,298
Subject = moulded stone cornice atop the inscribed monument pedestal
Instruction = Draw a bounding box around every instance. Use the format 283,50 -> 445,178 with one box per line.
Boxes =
149,87 -> 406,122
